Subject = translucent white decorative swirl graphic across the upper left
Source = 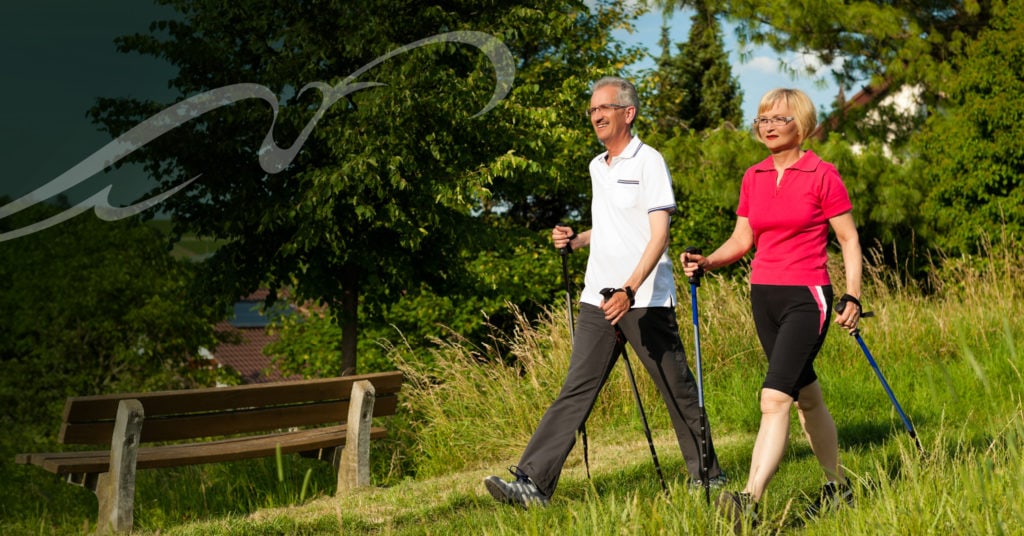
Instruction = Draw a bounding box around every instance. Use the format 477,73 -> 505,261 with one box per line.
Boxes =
0,32 -> 515,242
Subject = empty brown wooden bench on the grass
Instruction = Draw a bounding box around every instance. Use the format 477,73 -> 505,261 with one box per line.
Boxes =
15,372 -> 403,533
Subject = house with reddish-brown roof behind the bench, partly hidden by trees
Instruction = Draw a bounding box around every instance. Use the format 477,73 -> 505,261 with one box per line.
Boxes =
210,290 -> 301,383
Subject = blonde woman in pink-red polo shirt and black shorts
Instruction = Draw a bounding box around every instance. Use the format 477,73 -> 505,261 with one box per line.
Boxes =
680,89 -> 861,528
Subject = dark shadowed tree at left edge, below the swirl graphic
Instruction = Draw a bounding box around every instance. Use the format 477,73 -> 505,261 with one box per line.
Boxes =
0,198 -> 223,424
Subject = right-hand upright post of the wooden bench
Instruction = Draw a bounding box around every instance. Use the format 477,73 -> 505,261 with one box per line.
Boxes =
338,380 -> 376,493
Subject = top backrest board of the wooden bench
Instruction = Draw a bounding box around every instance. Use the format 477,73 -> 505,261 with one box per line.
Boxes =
63,372 -> 403,422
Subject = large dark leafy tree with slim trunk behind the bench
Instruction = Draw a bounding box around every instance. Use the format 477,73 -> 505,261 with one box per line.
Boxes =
92,0 -> 643,373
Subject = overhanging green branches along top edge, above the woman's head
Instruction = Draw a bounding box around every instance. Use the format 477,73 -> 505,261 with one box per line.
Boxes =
712,0 -> 1001,101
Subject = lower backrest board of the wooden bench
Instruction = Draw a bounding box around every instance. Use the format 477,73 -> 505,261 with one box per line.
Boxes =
59,395 -> 398,445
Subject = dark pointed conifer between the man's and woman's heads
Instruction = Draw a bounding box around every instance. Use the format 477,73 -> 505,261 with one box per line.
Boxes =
648,2 -> 743,133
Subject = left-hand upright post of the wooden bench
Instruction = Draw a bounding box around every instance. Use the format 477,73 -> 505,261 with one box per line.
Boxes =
96,400 -> 145,534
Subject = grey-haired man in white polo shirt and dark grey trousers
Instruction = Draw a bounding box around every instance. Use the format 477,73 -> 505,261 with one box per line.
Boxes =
484,77 -> 725,507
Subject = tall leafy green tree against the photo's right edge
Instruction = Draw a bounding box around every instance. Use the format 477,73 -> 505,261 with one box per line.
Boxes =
912,1 -> 1024,253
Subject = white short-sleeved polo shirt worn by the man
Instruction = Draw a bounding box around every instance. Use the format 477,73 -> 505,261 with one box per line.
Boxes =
581,136 -> 676,307
